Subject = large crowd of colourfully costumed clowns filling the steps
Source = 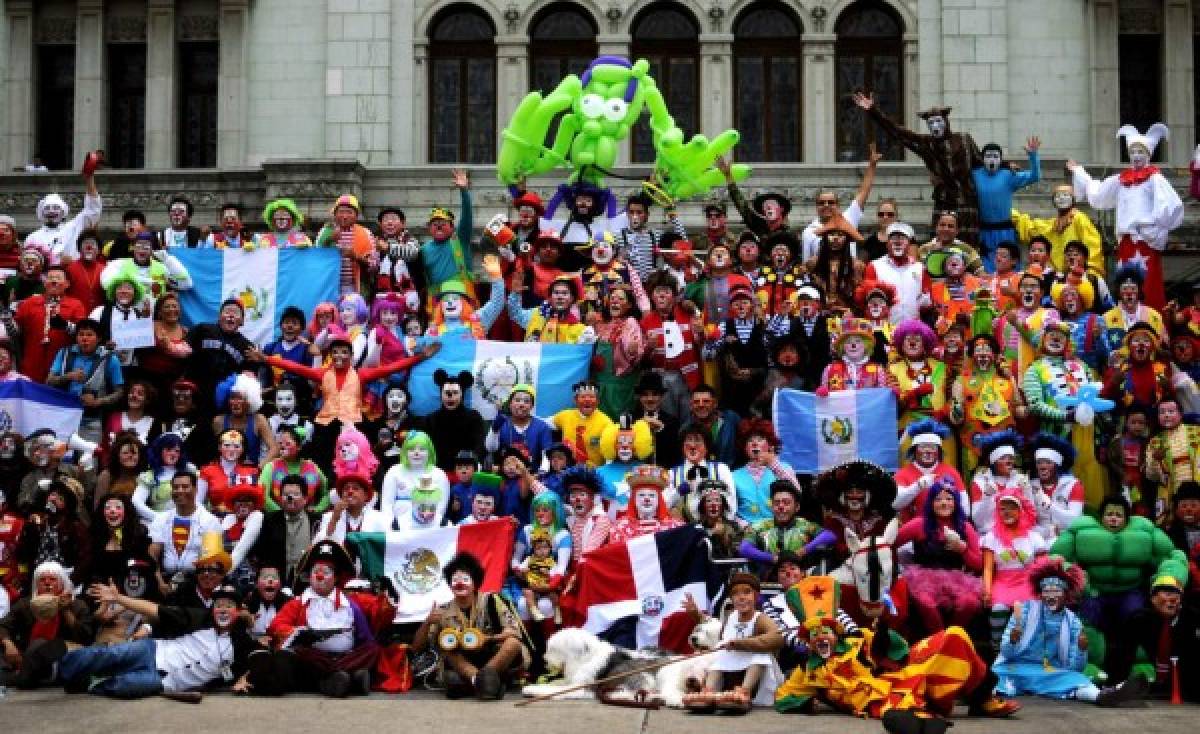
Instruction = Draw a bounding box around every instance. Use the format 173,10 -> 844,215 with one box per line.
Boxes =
0,110 -> 1200,730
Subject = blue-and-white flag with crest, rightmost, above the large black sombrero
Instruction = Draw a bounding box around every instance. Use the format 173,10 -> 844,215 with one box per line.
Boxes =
773,387 -> 899,474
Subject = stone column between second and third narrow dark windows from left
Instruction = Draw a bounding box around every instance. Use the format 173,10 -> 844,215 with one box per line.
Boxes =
145,0 -> 179,168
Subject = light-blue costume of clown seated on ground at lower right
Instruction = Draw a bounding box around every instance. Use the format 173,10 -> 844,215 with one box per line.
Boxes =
991,601 -> 1099,700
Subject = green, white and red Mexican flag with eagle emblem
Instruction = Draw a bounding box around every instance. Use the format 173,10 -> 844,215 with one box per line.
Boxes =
346,518 -> 514,624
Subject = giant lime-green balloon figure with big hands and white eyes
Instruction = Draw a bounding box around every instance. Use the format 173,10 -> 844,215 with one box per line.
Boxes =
496,56 -> 750,200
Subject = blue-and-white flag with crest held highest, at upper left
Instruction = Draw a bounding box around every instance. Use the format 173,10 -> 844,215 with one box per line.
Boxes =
170,247 -> 341,344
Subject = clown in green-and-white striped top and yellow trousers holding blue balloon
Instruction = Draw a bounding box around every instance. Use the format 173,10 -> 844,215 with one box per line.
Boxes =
1021,323 -> 1108,507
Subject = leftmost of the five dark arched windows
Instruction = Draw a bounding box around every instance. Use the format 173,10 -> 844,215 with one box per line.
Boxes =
430,5 -> 496,163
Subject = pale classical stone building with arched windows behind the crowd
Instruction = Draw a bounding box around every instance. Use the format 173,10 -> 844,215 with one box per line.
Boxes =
0,0 -> 1200,280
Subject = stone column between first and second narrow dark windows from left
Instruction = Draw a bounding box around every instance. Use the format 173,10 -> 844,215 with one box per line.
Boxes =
71,0 -> 108,160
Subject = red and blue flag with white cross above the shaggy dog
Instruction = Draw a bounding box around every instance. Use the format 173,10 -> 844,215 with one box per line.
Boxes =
574,525 -> 721,652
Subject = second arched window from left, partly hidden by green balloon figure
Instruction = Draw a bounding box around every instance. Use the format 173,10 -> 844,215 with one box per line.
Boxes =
529,2 -> 596,94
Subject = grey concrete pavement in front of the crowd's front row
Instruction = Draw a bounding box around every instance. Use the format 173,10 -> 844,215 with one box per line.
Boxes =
0,691 -> 1200,734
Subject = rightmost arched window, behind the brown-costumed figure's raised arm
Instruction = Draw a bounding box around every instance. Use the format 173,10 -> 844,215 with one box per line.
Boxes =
834,0 -> 904,161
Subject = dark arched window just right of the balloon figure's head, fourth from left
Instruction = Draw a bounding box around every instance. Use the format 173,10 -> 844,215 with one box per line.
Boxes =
733,2 -> 803,162
